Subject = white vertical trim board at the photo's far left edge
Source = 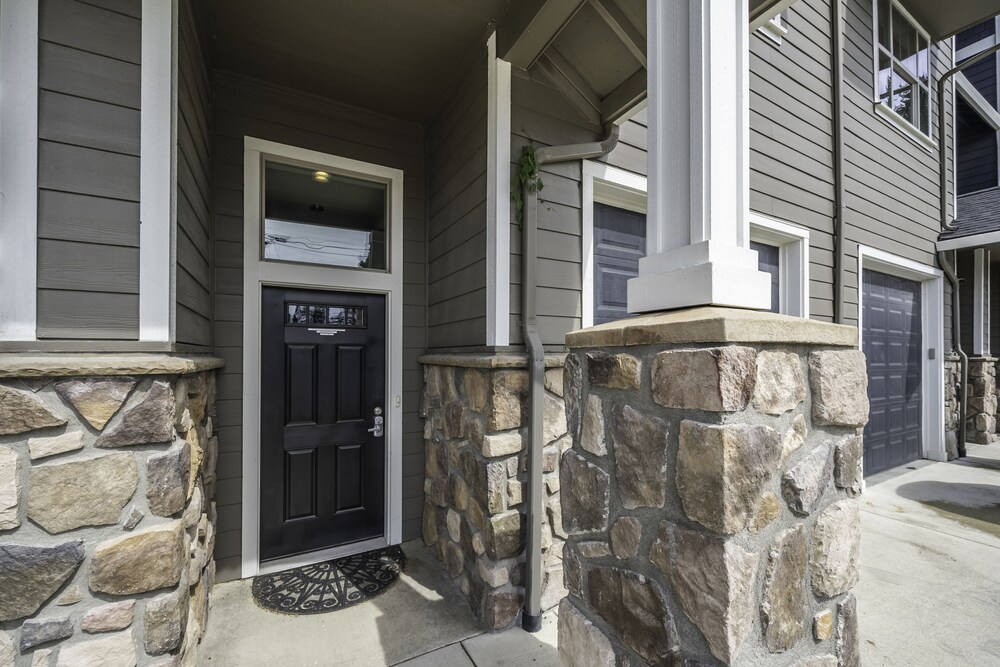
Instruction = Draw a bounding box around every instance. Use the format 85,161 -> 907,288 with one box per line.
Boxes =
0,0 -> 38,341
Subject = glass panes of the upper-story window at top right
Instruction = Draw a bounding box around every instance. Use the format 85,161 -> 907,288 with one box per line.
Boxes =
875,0 -> 931,137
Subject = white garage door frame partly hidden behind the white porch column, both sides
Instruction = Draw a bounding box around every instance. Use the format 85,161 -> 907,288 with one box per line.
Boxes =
580,160 -> 809,328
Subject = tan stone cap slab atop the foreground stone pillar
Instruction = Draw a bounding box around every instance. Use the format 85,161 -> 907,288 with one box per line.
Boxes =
566,306 -> 858,348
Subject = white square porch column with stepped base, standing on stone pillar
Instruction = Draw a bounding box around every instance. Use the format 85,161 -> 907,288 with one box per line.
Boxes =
628,0 -> 770,312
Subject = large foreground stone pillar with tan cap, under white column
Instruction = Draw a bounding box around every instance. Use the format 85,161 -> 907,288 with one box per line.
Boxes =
559,308 -> 868,667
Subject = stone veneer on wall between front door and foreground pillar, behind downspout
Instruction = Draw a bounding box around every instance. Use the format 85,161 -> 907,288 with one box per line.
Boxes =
421,355 -> 570,630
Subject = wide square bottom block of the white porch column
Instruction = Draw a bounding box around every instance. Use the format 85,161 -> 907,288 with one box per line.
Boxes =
628,260 -> 771,313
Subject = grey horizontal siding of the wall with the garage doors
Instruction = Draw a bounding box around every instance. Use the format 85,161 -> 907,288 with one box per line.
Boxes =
511,0 -> 953,347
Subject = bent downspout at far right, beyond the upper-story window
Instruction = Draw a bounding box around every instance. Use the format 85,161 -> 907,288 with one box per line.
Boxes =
937,44 -> 1000,456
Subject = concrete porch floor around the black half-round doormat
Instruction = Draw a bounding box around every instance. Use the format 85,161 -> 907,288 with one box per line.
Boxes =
198,541 -> 559,667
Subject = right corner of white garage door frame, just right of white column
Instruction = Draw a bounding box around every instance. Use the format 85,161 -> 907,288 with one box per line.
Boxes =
748,211 -> 809,318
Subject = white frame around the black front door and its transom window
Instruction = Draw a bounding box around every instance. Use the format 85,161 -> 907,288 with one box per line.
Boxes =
241,137 -> 403,577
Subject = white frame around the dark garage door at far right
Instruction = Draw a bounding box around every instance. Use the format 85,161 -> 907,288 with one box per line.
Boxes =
858,245 -> 948,465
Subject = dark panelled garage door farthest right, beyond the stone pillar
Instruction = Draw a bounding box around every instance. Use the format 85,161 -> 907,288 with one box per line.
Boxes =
862,271 -> 923,475
